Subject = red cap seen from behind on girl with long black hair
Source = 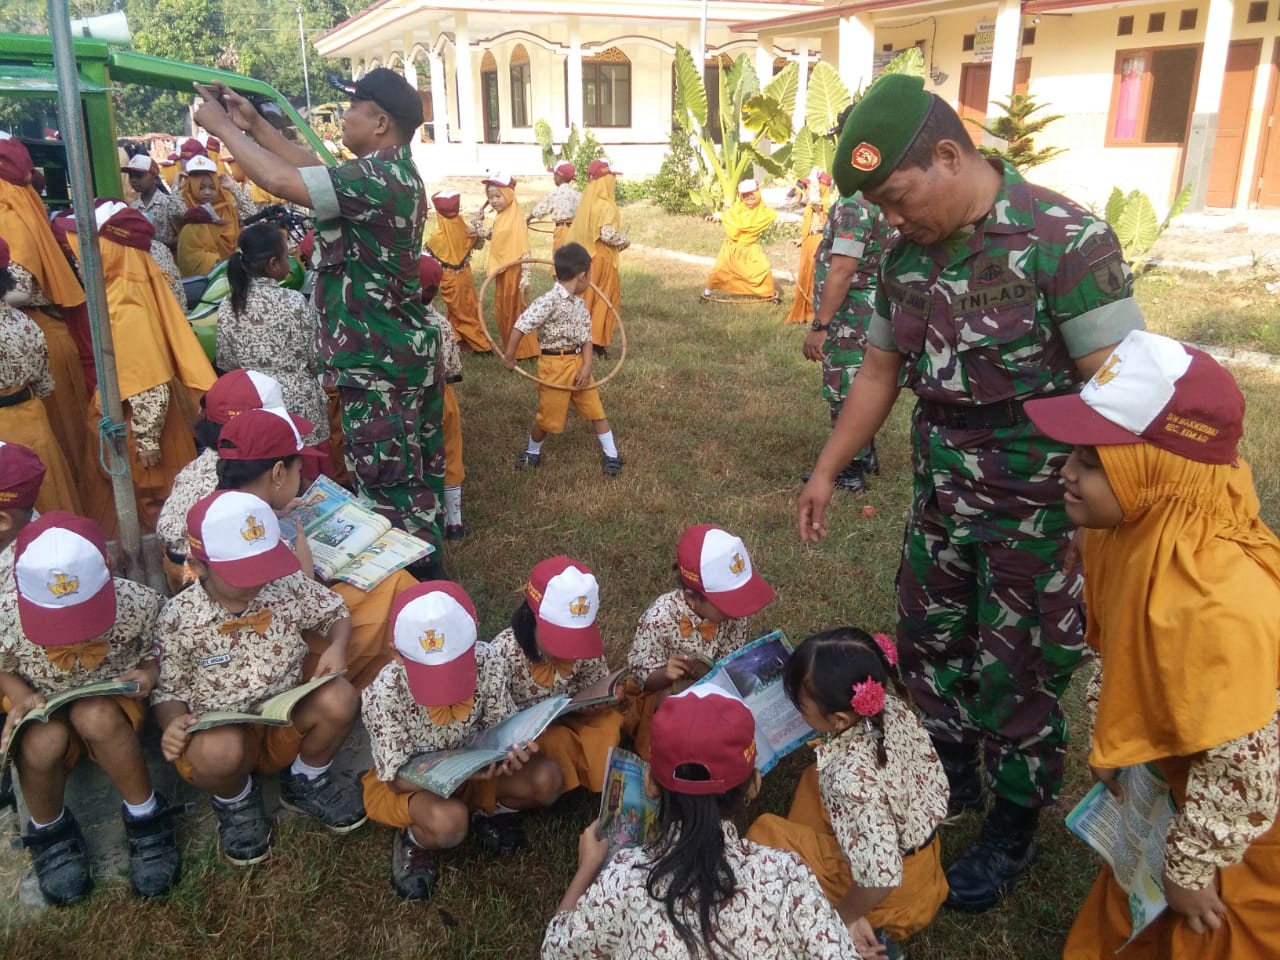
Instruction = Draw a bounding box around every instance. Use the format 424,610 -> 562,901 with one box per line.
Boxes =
649,684 -> 756,796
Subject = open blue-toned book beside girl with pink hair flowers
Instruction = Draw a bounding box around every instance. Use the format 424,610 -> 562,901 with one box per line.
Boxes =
695,630 -> 817,773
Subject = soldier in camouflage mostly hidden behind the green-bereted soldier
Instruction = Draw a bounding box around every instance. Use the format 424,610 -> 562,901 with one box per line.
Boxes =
804,188 -> 893,492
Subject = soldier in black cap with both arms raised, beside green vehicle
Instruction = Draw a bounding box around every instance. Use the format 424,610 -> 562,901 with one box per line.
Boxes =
197,68 -> 444,545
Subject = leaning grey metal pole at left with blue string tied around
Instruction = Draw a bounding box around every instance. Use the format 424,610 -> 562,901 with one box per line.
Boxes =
49,0 -> 146,582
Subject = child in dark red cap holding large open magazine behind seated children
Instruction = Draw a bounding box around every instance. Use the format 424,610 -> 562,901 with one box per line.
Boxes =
218,408 -> 417,690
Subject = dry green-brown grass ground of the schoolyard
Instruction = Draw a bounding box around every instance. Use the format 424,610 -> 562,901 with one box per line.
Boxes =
0,209 -> 1280,960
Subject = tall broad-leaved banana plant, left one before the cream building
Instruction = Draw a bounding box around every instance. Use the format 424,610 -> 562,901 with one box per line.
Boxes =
675,45 -> 795,211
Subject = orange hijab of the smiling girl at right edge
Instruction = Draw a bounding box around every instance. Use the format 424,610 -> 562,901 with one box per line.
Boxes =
1084,443 -> 1280,768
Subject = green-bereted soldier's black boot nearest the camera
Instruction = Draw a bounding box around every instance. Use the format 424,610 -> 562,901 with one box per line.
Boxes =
947,797 -> 1039,913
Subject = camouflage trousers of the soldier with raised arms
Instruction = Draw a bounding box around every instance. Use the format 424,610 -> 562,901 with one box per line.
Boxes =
338,381 -> 444,548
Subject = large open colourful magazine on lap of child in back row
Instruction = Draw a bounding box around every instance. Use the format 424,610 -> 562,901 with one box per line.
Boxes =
280,476 -> 434,590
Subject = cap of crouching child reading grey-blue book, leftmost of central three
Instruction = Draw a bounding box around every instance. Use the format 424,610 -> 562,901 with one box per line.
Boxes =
392,580 -> 479,707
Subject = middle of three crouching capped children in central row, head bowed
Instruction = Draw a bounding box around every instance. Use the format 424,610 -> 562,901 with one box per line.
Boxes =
493,557 -> 622,794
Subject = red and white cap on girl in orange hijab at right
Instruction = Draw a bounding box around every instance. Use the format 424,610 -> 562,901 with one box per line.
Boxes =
1024,330 -> 1244,463
